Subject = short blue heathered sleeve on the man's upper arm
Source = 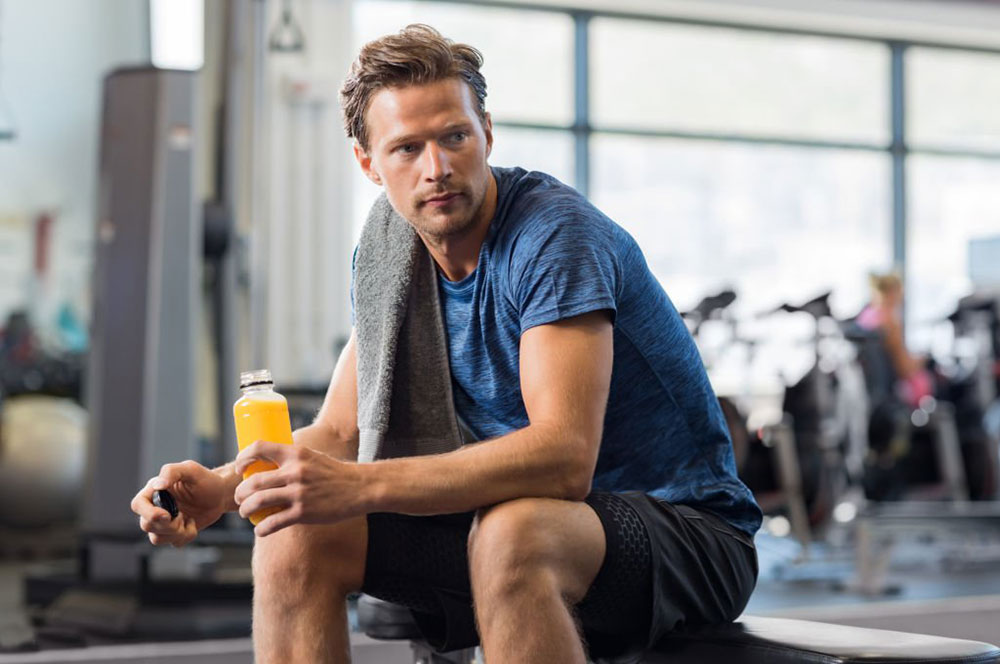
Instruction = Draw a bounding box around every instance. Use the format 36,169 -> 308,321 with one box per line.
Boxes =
510,211 -> 620,334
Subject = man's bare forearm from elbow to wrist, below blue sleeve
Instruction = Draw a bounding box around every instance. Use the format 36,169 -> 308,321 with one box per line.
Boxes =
358,425 -> 597,515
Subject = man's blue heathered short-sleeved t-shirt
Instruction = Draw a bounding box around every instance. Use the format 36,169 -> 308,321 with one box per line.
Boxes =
439,168 -> 761,535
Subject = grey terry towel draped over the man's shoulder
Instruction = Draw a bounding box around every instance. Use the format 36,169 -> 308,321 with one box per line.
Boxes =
354,194 -> 462,462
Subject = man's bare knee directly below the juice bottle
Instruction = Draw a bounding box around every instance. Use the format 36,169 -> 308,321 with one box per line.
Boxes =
253,517 -> 368,595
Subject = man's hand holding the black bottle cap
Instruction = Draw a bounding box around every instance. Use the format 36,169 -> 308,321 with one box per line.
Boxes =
132,461 -> 232,547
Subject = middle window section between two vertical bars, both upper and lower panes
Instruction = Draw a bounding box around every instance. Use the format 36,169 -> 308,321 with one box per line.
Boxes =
589,18 -> 892,316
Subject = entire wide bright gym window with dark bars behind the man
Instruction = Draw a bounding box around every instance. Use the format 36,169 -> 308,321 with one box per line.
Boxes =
356,0 -> 1000,346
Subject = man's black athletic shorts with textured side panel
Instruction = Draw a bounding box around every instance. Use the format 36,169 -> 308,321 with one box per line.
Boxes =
362,492 -> 757,657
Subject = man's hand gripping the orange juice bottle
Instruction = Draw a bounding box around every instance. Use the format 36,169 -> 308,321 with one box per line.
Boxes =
234,440 -> 365,537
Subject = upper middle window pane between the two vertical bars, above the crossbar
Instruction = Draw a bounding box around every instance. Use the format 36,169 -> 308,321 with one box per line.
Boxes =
590,18 -> 889,144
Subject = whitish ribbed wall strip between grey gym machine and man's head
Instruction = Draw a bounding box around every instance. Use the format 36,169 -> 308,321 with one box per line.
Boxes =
234,0 -> 352,386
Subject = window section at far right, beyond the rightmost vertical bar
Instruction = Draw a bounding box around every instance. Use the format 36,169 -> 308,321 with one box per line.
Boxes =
906,47 -> 1000,347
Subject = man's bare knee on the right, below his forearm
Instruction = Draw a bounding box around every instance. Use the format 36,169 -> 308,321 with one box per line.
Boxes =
469,498 -> 559,596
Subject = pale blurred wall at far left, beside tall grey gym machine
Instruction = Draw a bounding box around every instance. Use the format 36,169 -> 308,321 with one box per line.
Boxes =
0,0 -> 148,340
